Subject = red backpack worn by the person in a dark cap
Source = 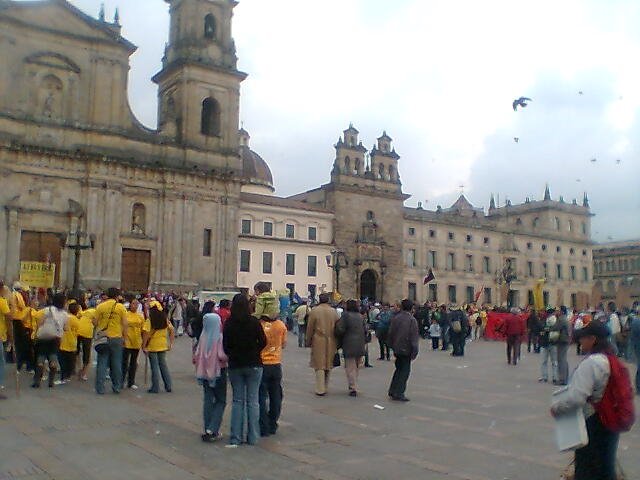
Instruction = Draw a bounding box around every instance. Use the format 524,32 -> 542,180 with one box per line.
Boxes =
593,353 -> 635,433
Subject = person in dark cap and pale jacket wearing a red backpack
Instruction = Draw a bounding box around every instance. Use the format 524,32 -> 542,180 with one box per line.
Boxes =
551,322 -> 635,480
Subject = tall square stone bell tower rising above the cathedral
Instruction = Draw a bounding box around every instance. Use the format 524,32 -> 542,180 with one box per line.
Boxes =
153,0 -> 246,153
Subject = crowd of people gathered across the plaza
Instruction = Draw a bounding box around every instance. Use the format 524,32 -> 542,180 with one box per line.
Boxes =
0,282 -> 640,480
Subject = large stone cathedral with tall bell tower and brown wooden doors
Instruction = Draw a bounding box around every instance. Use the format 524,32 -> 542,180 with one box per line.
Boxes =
0,0 -> 246,290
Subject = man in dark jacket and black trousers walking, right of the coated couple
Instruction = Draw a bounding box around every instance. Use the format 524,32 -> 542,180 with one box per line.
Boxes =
387,298 -> 420,402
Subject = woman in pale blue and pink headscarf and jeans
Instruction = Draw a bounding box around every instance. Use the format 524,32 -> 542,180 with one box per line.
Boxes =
193,302 -> 227,442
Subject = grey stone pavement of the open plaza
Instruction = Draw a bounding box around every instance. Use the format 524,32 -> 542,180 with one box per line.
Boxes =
0,335 -> 640,480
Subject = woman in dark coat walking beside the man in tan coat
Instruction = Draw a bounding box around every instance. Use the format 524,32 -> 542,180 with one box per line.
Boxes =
335,300 -> 366,397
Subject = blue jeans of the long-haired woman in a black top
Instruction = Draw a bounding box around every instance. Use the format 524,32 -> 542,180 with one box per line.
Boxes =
229,367 -> 262,445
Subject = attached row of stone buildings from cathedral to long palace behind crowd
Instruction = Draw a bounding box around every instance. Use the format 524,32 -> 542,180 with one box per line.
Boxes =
0,0 -> 593,306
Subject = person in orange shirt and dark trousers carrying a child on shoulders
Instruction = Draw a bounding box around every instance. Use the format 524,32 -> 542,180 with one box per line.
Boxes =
255,282 -> 287,437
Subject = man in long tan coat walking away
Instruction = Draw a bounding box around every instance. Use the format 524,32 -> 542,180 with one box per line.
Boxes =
306,293 -> 338,397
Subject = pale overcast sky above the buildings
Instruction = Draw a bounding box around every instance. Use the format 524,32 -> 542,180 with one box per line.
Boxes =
66,0 -> 640,241
